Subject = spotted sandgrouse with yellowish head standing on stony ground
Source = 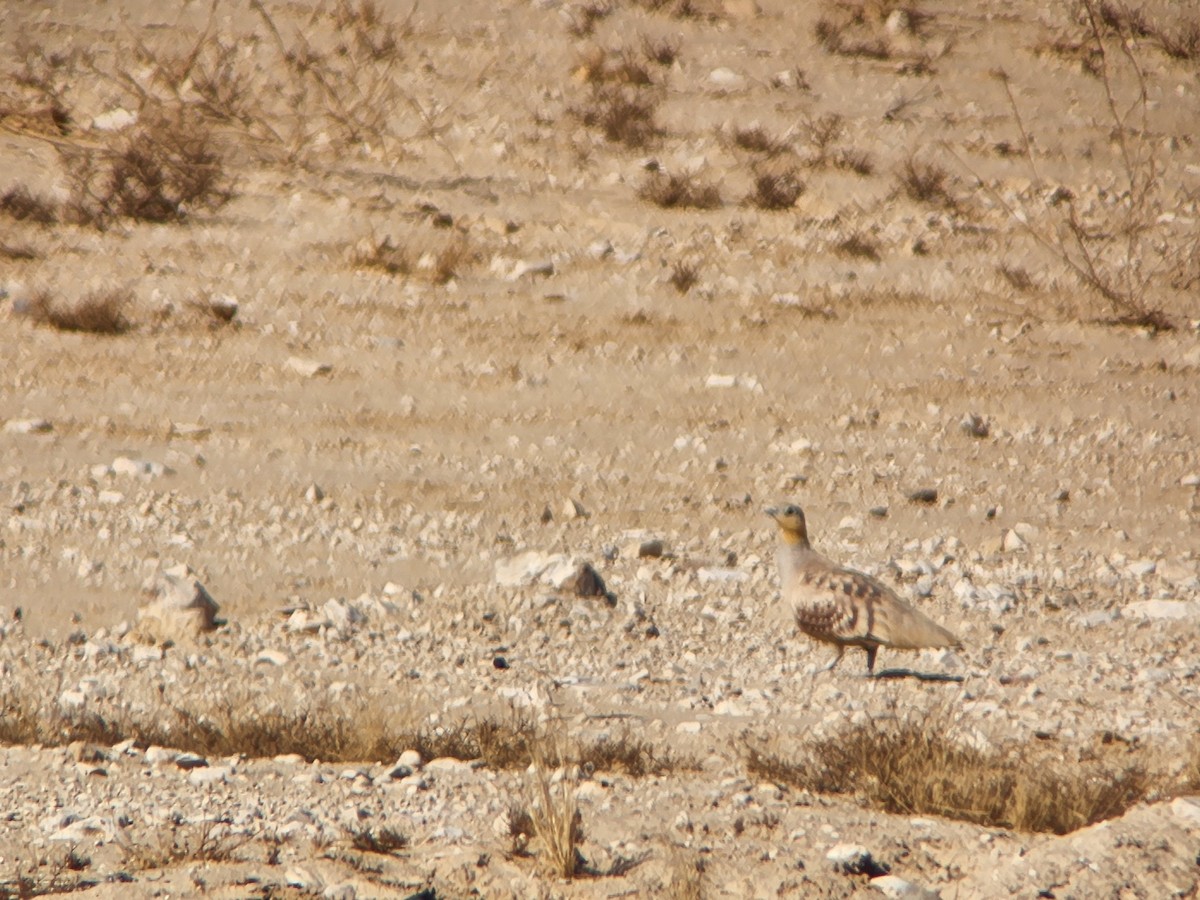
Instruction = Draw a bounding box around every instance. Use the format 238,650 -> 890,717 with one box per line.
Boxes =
767,504 -> 961,673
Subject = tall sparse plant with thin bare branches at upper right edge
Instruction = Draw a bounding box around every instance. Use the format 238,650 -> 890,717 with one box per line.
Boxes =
952,0 -> 1200,331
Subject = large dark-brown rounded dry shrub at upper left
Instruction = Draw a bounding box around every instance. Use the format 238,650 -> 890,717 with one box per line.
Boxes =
59,109 -> 233,227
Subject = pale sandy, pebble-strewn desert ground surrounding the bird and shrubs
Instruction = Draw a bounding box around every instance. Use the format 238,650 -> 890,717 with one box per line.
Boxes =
0,0 -> 1200,896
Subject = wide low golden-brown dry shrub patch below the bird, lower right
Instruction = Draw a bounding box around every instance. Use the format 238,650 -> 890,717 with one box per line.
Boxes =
746,714 -> 1164,834
